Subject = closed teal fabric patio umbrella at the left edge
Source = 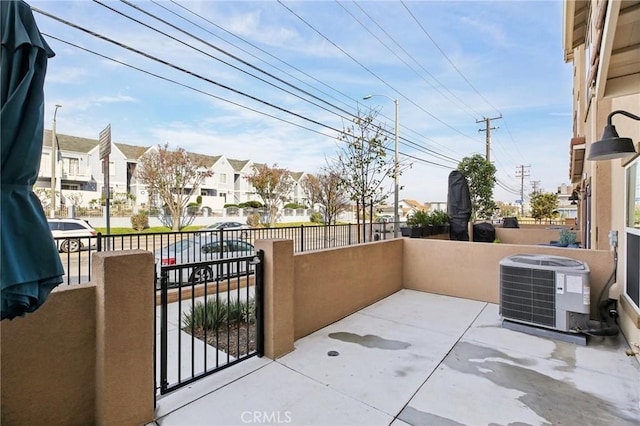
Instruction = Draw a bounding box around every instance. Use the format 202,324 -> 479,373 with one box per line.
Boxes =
0,0 -> 64,320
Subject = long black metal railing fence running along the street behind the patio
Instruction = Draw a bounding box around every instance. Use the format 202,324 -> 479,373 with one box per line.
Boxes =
55,223 -> 394,284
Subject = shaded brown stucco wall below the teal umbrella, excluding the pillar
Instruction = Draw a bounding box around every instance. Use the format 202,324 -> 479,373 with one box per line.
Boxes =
0,284 -> 96,425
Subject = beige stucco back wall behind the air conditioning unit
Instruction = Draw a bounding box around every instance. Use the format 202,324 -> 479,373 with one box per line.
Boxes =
403,239 -> 613,317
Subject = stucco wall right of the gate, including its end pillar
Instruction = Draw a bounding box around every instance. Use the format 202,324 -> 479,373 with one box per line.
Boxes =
256,239 -> 403,359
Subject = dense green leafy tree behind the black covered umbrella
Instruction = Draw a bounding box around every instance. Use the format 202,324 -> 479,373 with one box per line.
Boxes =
458,154 -> 496,221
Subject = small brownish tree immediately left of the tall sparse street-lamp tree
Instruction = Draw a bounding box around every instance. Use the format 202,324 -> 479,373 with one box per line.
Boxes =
302,168 -> 349,225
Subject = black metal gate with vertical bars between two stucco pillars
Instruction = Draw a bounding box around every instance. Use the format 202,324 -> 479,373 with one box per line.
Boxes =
156,250 -> 264,395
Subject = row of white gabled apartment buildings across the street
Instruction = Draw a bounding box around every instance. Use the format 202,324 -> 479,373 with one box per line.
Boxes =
35,130 -> 306,210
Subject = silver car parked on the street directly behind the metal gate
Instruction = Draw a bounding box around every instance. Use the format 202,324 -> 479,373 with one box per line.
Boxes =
154,237 -> 255,284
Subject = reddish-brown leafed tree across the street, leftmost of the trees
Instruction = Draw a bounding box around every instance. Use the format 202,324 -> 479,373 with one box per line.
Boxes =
135,144 -> 213,231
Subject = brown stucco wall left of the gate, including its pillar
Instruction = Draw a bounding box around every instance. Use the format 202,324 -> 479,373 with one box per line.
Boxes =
0,250 -> 155,425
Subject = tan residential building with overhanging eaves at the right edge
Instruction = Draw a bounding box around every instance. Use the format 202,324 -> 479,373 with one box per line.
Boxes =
563,0 -> 640,342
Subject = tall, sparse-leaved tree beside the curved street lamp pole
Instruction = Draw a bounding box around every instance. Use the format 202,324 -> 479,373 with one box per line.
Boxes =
329,110 -> 394,240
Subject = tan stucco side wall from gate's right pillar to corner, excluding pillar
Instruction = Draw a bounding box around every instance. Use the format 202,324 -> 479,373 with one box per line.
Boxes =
294,239 -> 404,339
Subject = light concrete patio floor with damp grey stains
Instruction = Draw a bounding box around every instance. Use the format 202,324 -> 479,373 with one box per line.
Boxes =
151,290 -> 640,426
